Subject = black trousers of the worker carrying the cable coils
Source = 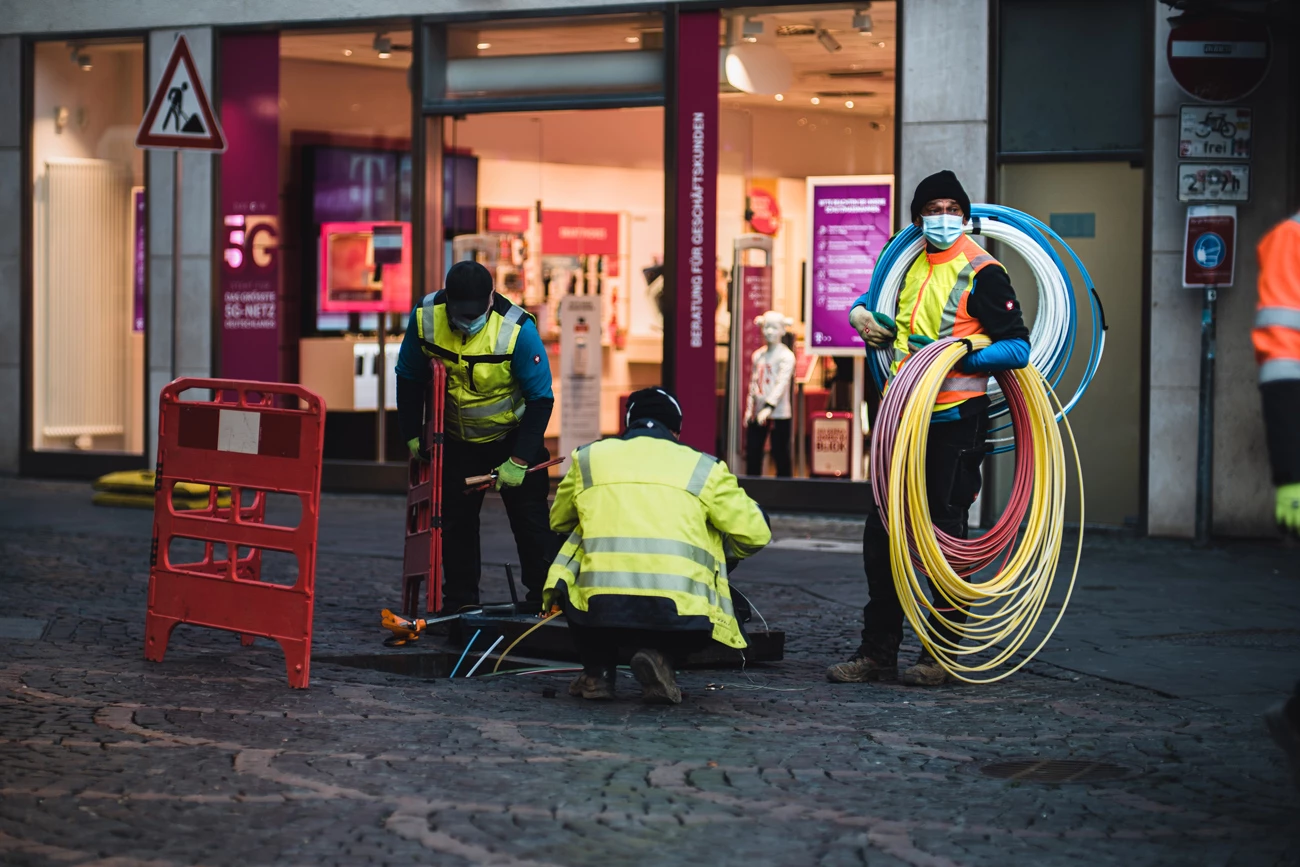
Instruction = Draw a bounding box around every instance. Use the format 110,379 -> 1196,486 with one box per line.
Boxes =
858,412 -> 988,666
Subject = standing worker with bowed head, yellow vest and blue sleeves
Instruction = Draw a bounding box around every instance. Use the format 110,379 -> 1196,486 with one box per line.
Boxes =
397,261 -> 560,614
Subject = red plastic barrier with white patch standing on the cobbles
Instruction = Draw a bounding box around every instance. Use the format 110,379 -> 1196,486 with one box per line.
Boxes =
144,378 -> 325,689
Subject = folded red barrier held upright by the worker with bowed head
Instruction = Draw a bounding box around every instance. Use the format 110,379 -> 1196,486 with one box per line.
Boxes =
402,359 -> 447,617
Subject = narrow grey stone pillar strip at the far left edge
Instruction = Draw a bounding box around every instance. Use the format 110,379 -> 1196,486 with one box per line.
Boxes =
0,36 -> 17,473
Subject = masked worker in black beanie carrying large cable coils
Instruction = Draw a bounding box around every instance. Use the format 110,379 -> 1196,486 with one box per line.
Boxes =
826,172 -> 1030,686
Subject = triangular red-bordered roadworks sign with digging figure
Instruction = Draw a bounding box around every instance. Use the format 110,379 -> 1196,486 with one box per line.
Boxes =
135,35 -> 226,152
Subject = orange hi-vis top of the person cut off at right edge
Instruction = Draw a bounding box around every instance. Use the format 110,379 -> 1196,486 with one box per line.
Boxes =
1252,213 -> 1300,385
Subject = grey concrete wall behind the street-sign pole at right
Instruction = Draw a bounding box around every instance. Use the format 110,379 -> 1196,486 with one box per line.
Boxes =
1148,0 -> 1295,537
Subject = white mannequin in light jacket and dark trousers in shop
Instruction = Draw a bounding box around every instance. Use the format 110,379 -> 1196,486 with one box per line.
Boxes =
745,311 -> 794,478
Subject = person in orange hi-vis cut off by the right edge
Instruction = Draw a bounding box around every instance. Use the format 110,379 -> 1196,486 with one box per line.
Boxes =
1253,213 -> 1300,786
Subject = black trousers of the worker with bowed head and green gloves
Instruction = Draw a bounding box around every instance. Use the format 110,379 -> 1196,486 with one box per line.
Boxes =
442,434 -> 564,614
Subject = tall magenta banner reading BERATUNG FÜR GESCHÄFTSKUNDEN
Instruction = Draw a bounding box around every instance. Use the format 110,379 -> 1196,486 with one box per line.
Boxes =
670,10 -> 719,454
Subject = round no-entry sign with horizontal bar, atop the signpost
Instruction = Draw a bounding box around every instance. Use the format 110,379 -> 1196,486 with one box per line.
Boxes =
1166,17 -> 1270,103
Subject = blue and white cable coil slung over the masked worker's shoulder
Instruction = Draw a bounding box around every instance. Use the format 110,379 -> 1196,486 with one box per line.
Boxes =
867,204 -> 1106,452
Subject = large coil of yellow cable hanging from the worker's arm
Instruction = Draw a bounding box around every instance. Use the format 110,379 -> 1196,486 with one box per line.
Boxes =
874,337 -> 1083,684
